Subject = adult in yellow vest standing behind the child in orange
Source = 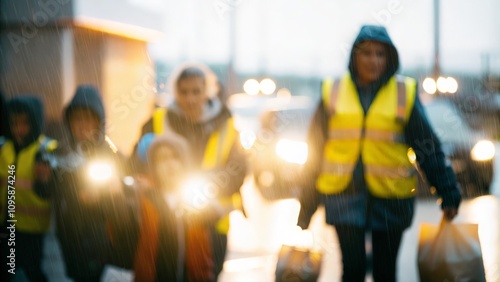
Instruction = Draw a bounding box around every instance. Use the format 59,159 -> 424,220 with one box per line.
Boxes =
133,65 -> 246,281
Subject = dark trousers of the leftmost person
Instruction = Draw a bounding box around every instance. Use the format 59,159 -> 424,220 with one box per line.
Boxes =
0,226 -> 47,282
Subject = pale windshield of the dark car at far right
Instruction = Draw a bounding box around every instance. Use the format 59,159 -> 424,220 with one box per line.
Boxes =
424,99 -> 482,143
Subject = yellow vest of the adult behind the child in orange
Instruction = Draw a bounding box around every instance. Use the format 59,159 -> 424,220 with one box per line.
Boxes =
153,108 -> 242,234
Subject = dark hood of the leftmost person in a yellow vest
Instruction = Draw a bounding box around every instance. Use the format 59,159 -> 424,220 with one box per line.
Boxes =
5,94 -> 44,145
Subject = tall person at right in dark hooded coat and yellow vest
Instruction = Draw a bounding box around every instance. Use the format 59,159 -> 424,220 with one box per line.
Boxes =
298,26 -> 461,281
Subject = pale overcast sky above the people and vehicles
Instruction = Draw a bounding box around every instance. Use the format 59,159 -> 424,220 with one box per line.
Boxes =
129,0 -> 500,76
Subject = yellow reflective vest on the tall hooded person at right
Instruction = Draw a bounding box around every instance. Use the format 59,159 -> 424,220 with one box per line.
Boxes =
316,74 -> 417,198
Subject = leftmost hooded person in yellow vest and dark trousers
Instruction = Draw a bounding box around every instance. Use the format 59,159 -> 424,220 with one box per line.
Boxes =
0,95 -> 57,281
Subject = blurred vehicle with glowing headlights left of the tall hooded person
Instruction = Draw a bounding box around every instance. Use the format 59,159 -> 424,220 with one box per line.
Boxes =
228,96 -> 314,200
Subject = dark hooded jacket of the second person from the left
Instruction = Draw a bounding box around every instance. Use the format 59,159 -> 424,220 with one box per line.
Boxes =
52,85 -> 133,281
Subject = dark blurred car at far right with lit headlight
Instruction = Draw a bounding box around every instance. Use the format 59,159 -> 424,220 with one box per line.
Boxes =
419,97 -> 495,197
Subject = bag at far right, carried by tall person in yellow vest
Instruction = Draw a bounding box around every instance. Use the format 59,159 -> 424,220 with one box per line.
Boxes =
418,219 -> 486,282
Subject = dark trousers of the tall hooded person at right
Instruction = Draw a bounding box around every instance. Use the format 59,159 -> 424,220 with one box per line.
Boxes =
335,225 -> 403,282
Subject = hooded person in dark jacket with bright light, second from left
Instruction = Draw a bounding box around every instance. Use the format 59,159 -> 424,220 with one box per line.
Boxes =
51,85 -> 128,281
